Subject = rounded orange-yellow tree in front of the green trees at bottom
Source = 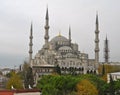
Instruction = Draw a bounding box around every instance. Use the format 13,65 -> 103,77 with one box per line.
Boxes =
76,79 -> 98,95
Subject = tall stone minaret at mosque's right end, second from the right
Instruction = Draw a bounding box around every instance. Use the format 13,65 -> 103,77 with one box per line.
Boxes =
95,14 -> 99,66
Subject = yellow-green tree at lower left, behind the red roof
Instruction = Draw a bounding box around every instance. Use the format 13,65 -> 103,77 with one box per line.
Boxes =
6,72 -> 23,89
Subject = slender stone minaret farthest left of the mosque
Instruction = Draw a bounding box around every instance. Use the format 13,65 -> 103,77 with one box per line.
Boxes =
29,23 -> 33,63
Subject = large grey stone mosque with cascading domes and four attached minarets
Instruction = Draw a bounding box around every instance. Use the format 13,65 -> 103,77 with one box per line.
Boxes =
29,8 -> 99,78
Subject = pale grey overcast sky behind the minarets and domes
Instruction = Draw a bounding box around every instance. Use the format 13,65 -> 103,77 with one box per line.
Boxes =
0,0 -> 120,68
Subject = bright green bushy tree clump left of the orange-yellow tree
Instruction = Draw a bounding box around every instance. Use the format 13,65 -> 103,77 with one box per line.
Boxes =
37,75 -> 79,95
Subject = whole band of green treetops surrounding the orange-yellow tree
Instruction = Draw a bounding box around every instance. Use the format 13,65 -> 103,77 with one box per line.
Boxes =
37,74 -> 108,95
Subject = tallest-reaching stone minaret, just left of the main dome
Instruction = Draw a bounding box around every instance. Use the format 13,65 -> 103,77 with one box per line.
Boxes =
44,8 -> 49,49
